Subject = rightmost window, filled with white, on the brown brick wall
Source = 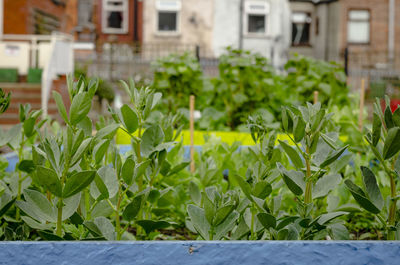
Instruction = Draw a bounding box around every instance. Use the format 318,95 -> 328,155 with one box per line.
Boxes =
347,10 -> 370,43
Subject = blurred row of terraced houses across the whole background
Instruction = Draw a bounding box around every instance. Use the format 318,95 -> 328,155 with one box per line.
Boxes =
0,0 -> 400,122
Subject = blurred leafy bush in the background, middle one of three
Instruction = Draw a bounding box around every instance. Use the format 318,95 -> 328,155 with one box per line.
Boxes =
210,48 -> 282,129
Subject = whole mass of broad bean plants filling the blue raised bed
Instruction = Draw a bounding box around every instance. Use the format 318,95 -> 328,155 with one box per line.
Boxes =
0,81 -> 400,240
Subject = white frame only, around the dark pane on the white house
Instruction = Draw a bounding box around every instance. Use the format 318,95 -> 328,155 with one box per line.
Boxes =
243,0 -> 270,36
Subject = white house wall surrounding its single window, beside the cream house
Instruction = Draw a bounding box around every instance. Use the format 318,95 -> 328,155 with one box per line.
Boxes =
213,0 -> 291,66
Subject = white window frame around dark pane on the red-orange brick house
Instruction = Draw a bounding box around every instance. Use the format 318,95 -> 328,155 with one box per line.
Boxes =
101,0 -> 129,34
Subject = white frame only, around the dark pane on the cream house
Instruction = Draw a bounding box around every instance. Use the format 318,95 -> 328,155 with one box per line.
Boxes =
155,0 -> 182,36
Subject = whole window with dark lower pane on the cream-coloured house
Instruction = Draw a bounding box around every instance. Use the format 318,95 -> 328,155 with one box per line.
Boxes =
157,0 -> 181,33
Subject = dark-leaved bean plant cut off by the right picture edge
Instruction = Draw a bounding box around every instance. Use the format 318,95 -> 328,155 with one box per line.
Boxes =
345,97 -> 400,240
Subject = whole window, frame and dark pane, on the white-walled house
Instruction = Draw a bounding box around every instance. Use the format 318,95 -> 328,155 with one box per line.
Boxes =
245,1 -> 269,35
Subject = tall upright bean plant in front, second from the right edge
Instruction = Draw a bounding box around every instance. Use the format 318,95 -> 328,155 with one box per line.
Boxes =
277,104 -> 347,239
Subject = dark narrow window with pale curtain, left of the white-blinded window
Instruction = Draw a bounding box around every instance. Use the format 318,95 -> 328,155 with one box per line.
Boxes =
292,12 -> 312,46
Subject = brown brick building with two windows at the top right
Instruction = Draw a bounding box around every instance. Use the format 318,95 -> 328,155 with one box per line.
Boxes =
290,0 -> 400,74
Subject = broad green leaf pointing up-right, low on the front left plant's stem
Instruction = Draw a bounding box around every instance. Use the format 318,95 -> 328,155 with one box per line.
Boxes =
62,171 -> 96,198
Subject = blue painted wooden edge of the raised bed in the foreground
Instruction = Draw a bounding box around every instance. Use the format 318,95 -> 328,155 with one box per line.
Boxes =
0,241 -> 400,265
